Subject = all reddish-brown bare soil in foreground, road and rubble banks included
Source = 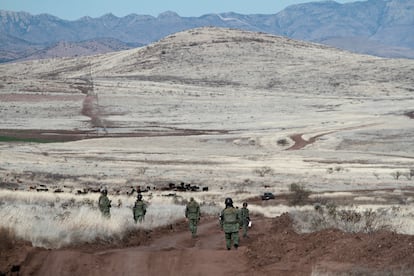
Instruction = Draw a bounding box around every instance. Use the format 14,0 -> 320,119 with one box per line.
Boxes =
0,214 -> 414,275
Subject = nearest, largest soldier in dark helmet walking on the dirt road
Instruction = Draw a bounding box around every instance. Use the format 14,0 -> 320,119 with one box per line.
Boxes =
220,197 -> 240,250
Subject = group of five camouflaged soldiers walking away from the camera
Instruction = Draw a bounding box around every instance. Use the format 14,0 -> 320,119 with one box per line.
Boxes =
98,189 -> 250,250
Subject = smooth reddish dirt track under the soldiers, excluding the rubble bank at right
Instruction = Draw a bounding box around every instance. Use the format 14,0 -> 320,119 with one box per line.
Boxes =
22,218 -> 249,275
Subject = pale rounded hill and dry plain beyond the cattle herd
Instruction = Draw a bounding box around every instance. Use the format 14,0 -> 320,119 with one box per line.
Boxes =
0,28 -> 414,191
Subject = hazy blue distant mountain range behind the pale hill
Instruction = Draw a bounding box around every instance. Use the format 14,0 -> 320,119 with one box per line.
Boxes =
0,0 -> 414,62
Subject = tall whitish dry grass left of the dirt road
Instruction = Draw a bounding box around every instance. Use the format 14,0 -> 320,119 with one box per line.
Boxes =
0,190 -> 219,248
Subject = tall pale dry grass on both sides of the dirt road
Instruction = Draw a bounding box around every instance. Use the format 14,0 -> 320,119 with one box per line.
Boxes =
0,190 -> 414,248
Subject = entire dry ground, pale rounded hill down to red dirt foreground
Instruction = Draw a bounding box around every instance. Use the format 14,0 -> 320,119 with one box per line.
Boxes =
0,25 -> 414,275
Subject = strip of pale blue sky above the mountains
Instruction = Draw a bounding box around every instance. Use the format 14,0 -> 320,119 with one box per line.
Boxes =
0,0 -> 356,20
